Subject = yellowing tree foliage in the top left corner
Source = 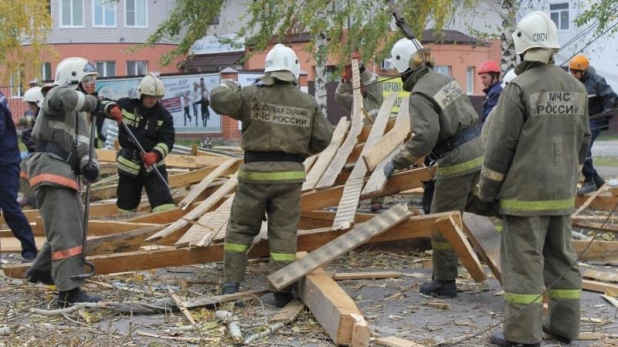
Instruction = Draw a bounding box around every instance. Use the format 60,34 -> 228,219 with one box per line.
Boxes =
0,0 -> 55,84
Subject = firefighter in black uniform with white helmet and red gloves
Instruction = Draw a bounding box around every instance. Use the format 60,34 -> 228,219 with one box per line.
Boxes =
109,73 -> 176,213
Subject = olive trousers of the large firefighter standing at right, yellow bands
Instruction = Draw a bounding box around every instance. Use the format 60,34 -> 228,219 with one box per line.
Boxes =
500,215 -> 582,344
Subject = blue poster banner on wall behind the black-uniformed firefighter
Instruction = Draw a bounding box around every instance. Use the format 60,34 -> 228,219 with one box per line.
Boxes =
96,74 -> 221,133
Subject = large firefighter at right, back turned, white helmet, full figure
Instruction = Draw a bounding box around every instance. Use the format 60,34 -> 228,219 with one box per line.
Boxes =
479,11 -> 590,346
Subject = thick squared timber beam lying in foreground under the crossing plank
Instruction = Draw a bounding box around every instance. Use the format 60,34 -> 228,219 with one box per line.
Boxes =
297,253 -> 362,345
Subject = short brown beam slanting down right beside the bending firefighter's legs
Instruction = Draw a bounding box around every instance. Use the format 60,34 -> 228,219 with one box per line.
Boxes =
436,217 -> 487,282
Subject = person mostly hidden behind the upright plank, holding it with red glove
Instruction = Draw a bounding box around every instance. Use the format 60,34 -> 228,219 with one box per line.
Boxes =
335,52 -> 384,212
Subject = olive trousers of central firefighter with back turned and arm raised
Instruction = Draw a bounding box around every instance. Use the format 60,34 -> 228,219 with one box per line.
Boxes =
224,182 -> 302,292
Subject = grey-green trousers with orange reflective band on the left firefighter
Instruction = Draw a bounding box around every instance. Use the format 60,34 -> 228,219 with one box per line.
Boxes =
32,186 -> 84,292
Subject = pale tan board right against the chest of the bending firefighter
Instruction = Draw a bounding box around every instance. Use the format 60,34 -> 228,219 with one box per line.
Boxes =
361,96 -> 411,170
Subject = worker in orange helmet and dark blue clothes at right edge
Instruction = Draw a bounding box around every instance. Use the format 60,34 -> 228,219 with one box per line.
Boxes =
569,54 -> 618,195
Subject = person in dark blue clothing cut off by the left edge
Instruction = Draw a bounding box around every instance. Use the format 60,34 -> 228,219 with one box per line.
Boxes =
0,92 -> 38,263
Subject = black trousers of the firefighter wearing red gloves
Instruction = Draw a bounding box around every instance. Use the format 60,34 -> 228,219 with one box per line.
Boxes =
116,166 -> 176,212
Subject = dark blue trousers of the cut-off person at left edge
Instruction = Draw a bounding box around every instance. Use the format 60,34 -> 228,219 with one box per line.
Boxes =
0,163 -> 37,258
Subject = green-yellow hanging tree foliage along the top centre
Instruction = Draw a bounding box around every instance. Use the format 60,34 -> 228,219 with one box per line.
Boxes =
134,0 -> 474,65
